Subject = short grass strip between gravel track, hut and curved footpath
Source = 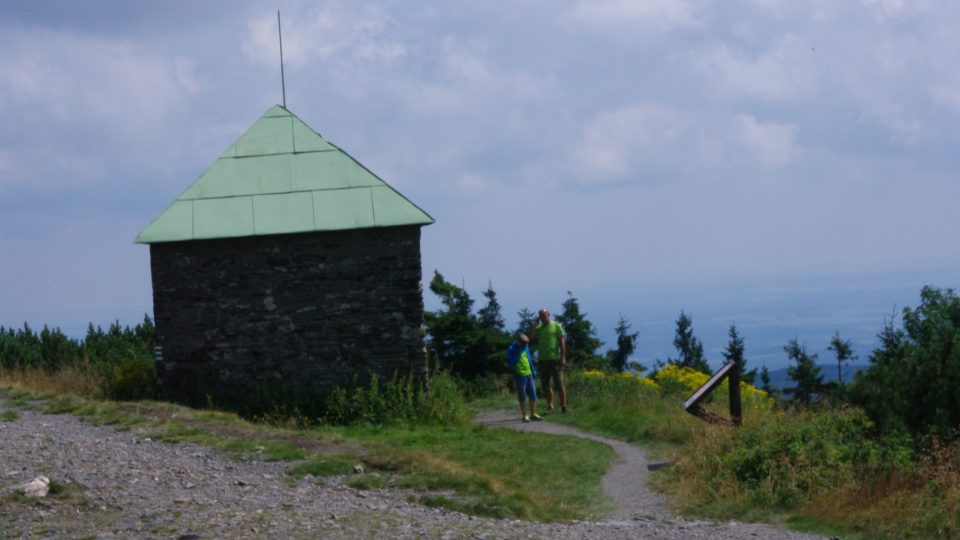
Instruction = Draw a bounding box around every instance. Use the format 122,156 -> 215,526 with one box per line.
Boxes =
1,376 -> 613,522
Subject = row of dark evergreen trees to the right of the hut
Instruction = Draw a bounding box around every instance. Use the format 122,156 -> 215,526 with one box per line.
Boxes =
425,271 -> 960,441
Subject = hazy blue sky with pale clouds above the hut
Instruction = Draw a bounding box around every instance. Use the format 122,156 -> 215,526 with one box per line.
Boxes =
0,0 -> 960,362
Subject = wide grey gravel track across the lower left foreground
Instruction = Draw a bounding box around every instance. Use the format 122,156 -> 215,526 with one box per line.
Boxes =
0,394 -> 824,540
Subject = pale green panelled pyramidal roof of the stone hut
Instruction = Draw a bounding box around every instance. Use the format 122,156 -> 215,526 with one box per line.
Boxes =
136,105 -> 433,244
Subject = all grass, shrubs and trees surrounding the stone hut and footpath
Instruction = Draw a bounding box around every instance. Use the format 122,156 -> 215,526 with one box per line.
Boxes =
0,284 -> 960,538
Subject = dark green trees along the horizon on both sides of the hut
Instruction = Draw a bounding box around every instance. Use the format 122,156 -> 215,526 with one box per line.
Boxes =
0,272 -> 960,446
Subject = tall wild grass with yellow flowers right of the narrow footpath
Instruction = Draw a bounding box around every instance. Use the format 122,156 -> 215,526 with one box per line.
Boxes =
556,367 -> 960,538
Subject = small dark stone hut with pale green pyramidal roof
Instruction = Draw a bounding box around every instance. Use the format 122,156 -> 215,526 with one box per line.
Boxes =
136,106 -> 433,412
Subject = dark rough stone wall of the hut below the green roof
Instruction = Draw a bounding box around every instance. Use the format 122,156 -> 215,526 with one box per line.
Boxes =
150,226 -> 426,412
